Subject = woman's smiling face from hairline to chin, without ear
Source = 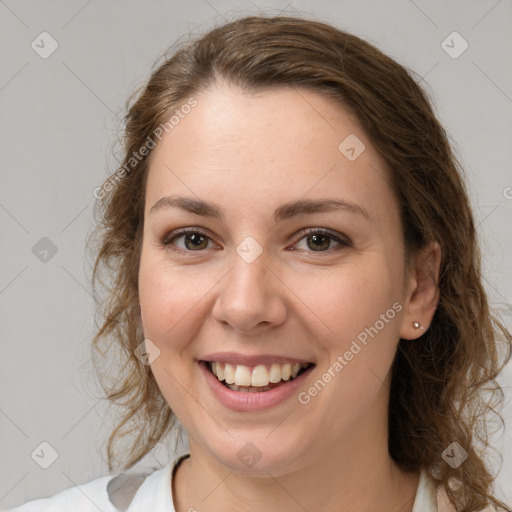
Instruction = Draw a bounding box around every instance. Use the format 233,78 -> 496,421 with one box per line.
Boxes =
139,83 -> 414,474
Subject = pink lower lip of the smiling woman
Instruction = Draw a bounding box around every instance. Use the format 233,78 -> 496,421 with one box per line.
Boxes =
199,362 -> 314,412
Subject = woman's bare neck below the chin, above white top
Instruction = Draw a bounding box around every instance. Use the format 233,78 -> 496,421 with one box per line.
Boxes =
173,422 -> 419,512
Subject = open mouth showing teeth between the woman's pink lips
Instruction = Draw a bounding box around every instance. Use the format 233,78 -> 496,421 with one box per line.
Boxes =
200,361 -> 315,393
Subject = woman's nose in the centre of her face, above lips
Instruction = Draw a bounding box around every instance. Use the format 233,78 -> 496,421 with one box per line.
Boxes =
212,249 -> 286,335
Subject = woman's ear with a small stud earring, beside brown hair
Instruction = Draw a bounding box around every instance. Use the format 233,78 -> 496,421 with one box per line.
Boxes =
400,241 -> 441,340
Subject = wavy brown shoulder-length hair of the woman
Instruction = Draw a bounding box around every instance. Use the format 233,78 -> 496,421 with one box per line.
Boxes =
86,15 -> 512,511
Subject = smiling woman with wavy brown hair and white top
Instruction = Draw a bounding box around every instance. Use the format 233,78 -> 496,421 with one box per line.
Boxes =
9,17 -> 512,512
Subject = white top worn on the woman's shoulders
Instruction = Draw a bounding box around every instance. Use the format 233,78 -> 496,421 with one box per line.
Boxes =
6,453 -> 440,512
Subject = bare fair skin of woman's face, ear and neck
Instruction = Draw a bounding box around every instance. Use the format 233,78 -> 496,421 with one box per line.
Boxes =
139,82 -> 441,512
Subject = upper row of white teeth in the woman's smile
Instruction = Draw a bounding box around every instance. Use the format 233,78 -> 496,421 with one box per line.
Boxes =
211,361 -> 309,386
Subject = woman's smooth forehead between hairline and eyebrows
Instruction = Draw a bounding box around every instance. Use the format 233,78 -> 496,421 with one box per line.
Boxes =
146,83 -> 393,224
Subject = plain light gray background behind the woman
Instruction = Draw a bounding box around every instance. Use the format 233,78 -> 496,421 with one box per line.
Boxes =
0,0 -> 512,508
